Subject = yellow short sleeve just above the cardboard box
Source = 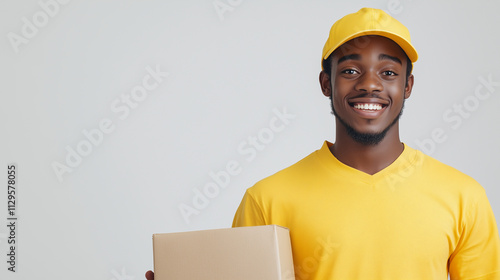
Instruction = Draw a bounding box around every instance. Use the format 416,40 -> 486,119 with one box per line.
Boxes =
233,190 -> 266,227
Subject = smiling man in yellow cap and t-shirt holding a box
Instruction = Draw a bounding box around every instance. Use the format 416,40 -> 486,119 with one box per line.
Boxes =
147,8 -> 500,280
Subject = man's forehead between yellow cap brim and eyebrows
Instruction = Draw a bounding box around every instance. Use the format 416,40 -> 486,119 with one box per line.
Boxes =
332,35 -> 406,61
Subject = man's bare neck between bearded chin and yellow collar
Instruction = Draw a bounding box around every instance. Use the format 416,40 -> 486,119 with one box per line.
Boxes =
330,122 -> 404,175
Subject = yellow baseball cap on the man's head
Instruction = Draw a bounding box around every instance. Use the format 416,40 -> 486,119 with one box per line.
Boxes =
321,8 -> 418,69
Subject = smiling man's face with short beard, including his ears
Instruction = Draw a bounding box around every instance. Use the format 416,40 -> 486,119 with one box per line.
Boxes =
321,36 -> 413,145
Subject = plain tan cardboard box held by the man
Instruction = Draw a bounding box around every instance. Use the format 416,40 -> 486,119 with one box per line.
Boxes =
153,225 -> 295,280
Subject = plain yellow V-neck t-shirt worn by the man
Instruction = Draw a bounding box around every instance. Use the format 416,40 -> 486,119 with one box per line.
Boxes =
233,142 -> 500,280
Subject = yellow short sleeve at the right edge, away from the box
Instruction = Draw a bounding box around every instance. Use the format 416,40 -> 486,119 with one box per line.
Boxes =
449,189 -> 500,280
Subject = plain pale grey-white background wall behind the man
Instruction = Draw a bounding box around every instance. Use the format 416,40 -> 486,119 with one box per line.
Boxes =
0,0 -> 500,280
